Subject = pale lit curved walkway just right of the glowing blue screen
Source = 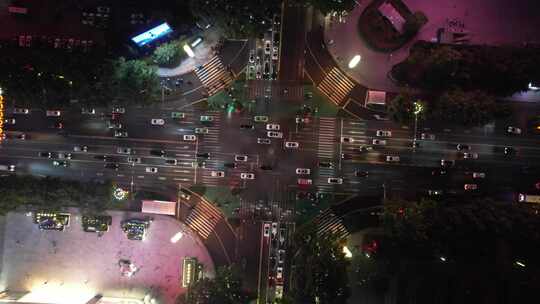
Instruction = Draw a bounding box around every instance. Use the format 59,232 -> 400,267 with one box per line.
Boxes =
157,26 -> 221,77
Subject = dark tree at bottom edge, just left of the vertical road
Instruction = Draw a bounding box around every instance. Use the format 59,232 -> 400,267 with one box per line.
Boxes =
186,266 -> 254,304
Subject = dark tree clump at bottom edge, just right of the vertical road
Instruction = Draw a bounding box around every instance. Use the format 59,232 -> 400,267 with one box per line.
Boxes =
290,224 -> 350,304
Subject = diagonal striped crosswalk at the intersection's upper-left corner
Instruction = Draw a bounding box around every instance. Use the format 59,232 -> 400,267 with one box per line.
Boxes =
195,56 -> 233,96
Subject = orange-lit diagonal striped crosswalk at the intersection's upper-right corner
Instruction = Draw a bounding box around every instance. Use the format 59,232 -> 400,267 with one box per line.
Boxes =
317,67 -> 355,106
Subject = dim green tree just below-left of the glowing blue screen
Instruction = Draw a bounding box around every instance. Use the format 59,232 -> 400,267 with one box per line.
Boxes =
112,57 -> 159,104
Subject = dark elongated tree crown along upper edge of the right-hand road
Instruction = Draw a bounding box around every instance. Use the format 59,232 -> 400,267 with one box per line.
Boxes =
429,89 -> 507,126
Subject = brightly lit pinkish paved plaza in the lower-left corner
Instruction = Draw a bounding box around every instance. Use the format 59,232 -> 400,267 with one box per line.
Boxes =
0,209 -> 214,304
